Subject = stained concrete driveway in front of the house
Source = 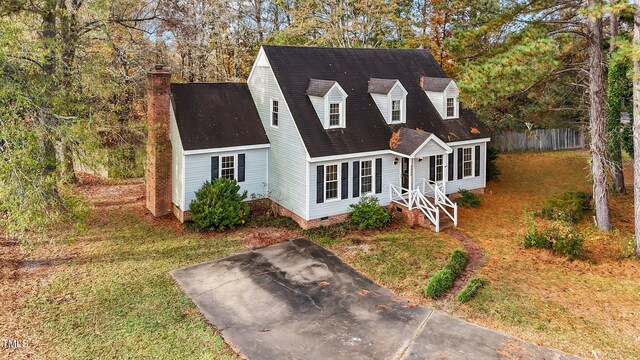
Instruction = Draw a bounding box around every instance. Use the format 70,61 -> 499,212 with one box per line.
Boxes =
171,239 -> 574,360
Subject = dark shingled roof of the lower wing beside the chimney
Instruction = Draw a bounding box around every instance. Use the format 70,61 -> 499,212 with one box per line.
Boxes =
171,83 -> 269,150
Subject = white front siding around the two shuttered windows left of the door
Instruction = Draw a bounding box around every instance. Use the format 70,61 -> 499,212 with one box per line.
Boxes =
308,155 -> 400,220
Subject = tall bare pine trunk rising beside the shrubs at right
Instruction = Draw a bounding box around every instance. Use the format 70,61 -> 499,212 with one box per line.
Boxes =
587,0 -> 611,231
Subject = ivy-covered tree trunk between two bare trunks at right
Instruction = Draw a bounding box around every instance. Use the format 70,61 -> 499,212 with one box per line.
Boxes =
607,12 -> 627,194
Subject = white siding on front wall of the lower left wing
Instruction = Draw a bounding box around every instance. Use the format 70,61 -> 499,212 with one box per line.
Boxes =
184,148 -> 269,209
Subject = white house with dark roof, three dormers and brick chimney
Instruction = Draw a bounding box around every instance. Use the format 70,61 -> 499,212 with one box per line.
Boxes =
147,46 -> 490,230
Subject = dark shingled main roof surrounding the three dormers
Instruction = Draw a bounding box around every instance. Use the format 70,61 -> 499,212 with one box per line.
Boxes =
263,46 -> 490,157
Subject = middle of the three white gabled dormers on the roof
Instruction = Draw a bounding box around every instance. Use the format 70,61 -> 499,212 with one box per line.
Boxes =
369,78 -> 407,124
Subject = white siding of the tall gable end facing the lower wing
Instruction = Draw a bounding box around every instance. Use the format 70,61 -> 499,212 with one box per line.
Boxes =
248,57 -> 307,219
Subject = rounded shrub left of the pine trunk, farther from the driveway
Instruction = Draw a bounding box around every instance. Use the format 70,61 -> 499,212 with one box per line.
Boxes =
541,191 -> 591,223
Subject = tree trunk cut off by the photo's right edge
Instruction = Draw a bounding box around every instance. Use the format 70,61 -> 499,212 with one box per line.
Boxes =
633,0 -> 640,258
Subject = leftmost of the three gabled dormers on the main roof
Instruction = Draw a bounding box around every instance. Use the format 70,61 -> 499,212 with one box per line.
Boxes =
307,79 -> 348,129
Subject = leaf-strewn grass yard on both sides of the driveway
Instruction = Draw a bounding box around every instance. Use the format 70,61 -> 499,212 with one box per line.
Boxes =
0,152 -> 640,359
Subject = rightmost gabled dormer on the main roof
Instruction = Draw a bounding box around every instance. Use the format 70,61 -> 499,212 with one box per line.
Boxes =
420,76 -> 460,119
